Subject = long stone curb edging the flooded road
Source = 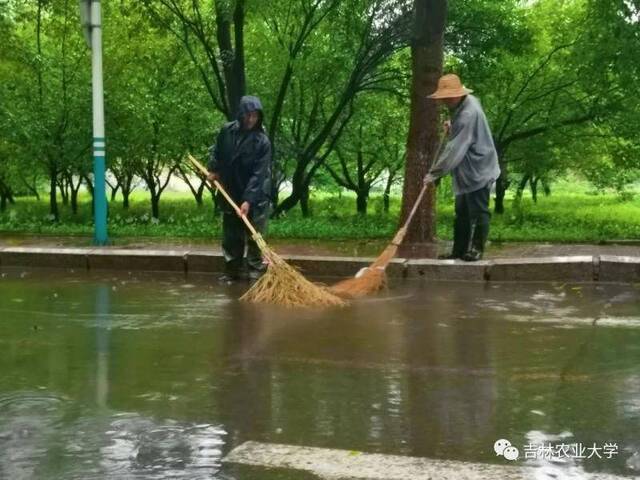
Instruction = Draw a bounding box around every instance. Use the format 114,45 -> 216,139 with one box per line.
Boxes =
0,247 -> 640,283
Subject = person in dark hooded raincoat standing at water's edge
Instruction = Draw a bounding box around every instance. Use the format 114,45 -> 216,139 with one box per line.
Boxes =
207,96 -> 271,282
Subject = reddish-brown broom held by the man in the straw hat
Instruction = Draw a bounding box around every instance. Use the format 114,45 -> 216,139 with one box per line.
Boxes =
330,141 -> 445,298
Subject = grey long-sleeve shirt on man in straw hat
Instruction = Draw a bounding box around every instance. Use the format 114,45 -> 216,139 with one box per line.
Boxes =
429,95 -> 500,195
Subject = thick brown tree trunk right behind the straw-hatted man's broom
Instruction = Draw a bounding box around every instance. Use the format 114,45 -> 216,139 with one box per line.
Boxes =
401,0 -> 447,256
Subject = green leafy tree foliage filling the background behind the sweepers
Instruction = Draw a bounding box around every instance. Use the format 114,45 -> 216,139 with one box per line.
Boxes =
0,0 -> 640,222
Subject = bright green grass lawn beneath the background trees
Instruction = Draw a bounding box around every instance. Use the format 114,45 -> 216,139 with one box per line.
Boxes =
0,183 -> 640,243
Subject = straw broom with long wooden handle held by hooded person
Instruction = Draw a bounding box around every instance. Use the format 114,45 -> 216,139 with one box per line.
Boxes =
187,155 -> 345,307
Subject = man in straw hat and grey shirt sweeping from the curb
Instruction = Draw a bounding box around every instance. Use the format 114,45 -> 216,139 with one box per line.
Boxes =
424,74 -> 500,262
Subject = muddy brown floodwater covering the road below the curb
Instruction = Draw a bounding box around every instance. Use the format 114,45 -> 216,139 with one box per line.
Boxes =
0,268 -> 640,480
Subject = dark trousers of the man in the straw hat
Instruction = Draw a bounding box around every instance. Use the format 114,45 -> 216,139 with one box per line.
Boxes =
451,186 -> 491,258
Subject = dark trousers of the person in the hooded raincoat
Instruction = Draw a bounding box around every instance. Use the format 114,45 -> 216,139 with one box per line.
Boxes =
222,208 -> 269,275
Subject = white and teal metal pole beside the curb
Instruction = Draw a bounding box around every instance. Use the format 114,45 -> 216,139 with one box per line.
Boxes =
91,0 -> 109,245
